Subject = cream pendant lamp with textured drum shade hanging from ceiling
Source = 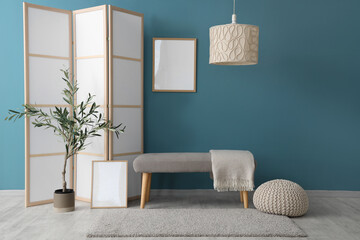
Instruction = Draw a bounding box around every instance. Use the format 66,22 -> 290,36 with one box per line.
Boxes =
209,0 -> 259,65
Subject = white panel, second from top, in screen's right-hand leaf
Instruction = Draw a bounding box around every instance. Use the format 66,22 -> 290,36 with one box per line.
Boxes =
113,58 -> 142,105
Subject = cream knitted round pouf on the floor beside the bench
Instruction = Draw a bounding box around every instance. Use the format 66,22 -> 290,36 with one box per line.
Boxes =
253,179 -> 309,217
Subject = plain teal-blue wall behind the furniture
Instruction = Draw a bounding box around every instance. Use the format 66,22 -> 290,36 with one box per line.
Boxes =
0,0 -> 360,190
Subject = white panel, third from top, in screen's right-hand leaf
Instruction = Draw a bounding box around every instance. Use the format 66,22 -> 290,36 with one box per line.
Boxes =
113,108 -> 142,154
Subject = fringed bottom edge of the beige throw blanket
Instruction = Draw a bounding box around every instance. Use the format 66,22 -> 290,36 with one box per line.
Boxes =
214,179 -> 254,192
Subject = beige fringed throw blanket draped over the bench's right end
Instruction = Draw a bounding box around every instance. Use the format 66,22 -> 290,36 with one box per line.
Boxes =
210,150 -> 255,192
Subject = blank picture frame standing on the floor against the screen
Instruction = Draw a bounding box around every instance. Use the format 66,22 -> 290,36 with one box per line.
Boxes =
91,160 -> 128,208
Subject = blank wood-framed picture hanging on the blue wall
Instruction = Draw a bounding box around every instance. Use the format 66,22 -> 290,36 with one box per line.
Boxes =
152,38 -> 196,92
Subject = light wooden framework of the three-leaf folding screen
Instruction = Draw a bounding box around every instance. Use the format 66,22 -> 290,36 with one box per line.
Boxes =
23,2 -> 144,207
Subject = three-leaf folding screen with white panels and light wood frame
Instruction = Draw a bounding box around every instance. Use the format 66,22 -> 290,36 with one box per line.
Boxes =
24,3 -> 143,206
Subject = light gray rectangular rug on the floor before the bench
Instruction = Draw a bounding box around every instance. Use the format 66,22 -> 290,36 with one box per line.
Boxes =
87,209 -> 307,238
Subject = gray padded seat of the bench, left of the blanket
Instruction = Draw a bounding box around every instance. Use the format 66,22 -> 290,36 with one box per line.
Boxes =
134,153 -> 211,173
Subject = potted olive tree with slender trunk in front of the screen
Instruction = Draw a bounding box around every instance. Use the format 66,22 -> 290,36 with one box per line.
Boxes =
5,70 -> 125,212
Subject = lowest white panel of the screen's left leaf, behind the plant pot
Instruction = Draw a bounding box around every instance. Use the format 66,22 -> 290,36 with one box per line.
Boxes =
30,155 -> 70,202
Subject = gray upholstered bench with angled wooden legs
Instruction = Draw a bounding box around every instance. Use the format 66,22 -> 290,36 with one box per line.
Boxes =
133,153 -> 249,208
